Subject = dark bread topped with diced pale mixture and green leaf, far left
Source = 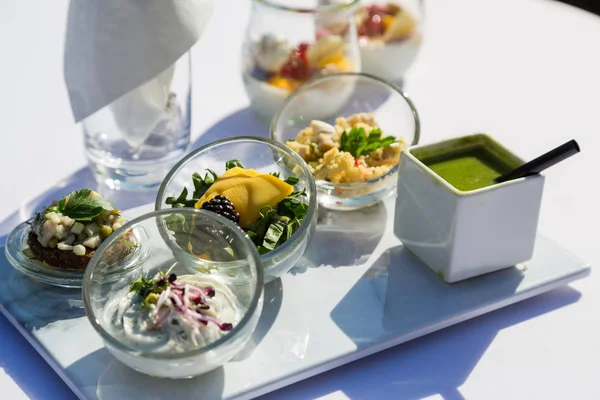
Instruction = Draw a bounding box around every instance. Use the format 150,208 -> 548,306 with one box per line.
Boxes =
24,188 -> 135,269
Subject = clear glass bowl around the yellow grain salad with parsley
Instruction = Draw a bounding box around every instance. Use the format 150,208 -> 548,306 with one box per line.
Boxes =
271,73 -> 420,210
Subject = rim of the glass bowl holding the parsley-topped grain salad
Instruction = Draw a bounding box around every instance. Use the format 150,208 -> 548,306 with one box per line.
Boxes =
269,72 -> 421,189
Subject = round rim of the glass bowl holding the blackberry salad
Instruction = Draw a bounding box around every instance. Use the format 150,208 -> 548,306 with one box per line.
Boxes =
154,136 -> 317,270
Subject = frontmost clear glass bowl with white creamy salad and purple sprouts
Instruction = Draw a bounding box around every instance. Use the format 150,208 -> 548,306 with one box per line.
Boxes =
83,209 -> 264,378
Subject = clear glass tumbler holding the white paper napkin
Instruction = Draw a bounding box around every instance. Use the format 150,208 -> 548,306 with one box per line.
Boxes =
82,52 -> 192,191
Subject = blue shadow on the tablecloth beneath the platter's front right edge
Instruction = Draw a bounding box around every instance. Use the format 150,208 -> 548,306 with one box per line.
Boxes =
260,286 -> 580,400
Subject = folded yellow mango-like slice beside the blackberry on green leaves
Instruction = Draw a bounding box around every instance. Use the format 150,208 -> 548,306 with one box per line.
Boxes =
194,167 -> 294,227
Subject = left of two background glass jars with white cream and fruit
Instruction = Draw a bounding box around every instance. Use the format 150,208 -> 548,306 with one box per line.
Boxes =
242,0 -> 360,120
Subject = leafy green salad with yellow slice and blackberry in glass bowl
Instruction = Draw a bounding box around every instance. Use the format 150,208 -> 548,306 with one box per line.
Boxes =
165,160 -> 308,255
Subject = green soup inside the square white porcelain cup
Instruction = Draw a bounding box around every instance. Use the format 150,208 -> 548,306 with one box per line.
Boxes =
421,146 -> 510,192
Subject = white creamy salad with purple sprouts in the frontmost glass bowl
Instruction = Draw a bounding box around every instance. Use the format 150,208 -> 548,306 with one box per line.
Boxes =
104,274 -> 241,353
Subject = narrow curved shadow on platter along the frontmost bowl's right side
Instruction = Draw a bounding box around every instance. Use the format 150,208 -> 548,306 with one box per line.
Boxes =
230,279 -> 283,362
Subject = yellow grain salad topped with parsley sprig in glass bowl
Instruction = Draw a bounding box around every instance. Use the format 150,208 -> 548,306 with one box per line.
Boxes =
286,113 -> 405,183
